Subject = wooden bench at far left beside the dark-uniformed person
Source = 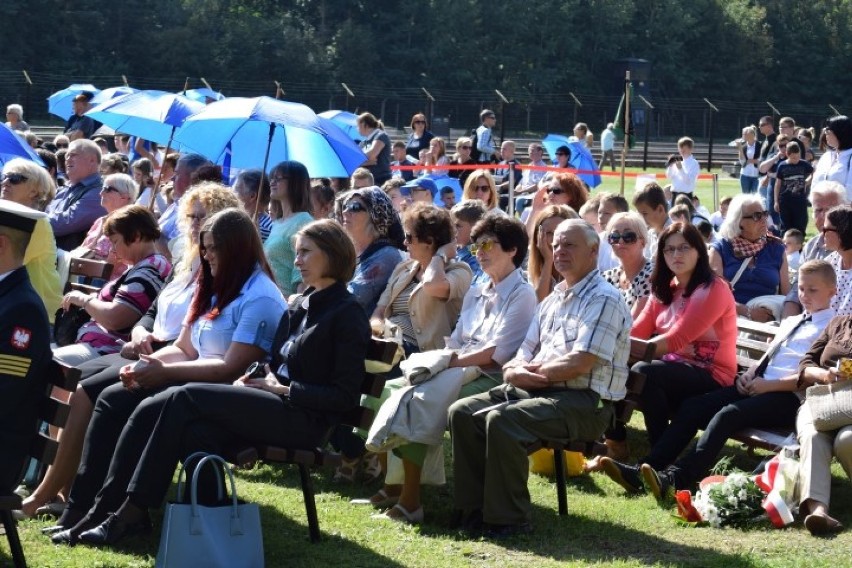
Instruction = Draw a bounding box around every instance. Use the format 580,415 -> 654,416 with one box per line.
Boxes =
0,360 -> 80,568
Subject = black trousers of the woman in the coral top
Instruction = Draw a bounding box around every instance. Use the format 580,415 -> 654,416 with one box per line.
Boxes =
633,360 -> 720,446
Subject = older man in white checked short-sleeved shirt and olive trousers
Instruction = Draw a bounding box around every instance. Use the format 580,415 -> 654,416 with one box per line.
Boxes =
449,219 -> 632,537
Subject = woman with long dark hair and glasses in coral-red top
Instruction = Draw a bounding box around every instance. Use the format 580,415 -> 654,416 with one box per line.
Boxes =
630,223 -> 737,445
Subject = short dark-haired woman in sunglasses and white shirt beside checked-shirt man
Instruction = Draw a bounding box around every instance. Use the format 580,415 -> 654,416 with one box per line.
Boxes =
355,211 -> 536,523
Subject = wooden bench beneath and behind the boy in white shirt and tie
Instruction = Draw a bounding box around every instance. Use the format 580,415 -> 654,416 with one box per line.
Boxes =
732,318 -> 795,454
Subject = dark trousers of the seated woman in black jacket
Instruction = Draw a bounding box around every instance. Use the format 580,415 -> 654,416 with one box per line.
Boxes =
128,383 -> 334,508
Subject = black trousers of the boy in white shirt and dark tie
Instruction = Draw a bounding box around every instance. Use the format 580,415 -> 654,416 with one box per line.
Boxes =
640,386 -> 799,489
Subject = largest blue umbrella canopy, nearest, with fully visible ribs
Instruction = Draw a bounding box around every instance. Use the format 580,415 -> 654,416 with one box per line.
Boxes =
175,97 -> 367,177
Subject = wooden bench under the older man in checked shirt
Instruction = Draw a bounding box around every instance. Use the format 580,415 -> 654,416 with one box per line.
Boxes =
527,337 -> 655,515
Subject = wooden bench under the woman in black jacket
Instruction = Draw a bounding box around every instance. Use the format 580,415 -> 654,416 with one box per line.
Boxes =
226,338 -> 397,542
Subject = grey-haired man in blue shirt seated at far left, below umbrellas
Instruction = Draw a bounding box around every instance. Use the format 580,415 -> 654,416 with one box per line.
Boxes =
45,140 -> 106,251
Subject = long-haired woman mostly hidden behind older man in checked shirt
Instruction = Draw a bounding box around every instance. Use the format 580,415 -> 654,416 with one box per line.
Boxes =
527,205 -> 579,302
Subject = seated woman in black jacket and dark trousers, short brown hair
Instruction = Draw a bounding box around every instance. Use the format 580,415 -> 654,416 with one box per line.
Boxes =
80,219 -> 370,545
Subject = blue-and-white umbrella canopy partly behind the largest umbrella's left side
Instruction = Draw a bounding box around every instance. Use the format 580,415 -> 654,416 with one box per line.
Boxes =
86,91 -> 204,145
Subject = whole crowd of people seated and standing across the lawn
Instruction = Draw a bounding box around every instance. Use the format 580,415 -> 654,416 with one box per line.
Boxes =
0,102 -> 852,560
